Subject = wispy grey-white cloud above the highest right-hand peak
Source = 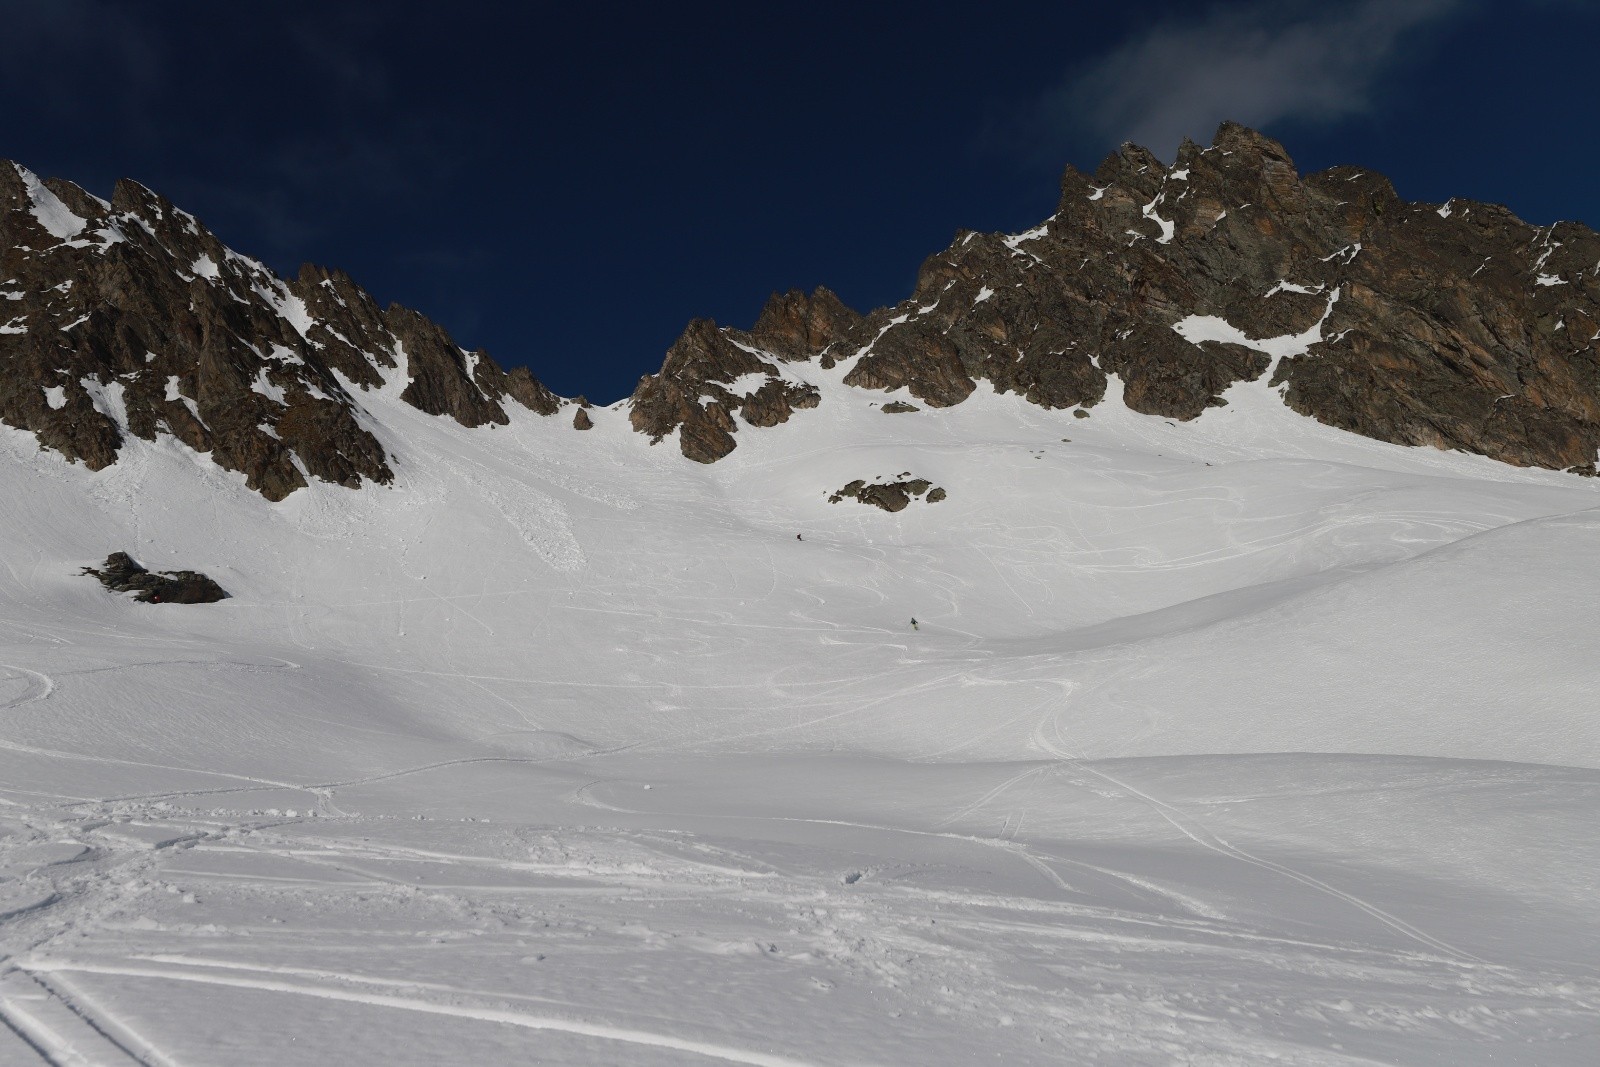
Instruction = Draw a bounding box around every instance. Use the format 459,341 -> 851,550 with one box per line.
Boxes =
1045,0 -> 1469,158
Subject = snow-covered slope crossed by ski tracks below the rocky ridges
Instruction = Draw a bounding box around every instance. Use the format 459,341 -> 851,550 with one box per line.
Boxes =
0,355 -> 1600,1067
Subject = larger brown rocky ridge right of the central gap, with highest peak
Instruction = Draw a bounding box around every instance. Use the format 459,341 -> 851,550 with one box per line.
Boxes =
634,123 -> 1600,472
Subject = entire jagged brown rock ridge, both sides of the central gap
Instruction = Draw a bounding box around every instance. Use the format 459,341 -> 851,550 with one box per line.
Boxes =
0,123 -> 1600,499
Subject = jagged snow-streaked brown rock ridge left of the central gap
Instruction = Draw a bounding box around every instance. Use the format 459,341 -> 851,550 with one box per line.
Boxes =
0,162 -> 558,499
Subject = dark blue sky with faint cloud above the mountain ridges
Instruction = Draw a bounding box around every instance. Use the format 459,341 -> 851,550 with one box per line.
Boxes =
0,0 -> 1600,402
